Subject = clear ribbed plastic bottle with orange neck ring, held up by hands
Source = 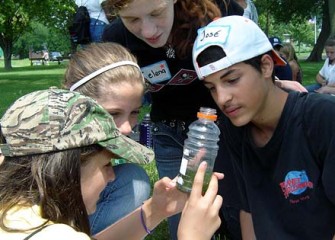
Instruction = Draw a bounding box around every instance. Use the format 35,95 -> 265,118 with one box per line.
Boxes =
177,108 -> 220,192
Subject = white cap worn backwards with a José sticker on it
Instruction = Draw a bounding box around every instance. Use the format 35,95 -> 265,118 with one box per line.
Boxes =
192,16 -> 286,80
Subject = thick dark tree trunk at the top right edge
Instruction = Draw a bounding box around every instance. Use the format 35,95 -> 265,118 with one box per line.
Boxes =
306,0 -> 335,62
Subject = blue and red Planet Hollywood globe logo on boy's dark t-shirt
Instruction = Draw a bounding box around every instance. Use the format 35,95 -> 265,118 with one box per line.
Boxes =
279,170 -> 313,198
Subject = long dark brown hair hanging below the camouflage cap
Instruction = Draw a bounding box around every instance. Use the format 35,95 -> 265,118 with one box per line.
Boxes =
0,145 -> 101,235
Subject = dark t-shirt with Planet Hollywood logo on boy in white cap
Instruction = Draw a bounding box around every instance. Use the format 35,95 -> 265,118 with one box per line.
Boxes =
221,92 -> 335,240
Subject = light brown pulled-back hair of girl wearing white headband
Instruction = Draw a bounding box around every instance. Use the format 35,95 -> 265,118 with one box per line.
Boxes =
63,43 -> 144,99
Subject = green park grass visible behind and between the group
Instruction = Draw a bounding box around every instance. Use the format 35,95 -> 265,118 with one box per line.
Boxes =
0,59 -> 323,240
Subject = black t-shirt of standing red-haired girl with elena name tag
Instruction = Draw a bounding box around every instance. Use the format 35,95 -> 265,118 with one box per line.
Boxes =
102,1 -> 243,122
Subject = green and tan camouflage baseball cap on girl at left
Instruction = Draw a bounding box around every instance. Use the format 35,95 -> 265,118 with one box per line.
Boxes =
0,89 -> 154,164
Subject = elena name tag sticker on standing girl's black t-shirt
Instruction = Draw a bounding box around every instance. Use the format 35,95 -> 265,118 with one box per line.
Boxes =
141,61 -> 171,84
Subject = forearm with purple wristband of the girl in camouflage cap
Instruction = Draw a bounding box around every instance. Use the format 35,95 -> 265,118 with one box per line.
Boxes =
94,198 -> 165,240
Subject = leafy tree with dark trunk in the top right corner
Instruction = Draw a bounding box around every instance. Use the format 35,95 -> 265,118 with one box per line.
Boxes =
255,0 -> 335,61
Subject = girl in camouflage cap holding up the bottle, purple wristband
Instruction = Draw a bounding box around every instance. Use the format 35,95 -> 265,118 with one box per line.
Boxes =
0,89 -> 223,240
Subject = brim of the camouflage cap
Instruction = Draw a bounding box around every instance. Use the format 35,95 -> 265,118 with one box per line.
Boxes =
98,135 -> 155,164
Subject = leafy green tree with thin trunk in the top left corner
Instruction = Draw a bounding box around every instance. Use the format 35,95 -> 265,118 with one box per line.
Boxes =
0,0 -> 75,69
